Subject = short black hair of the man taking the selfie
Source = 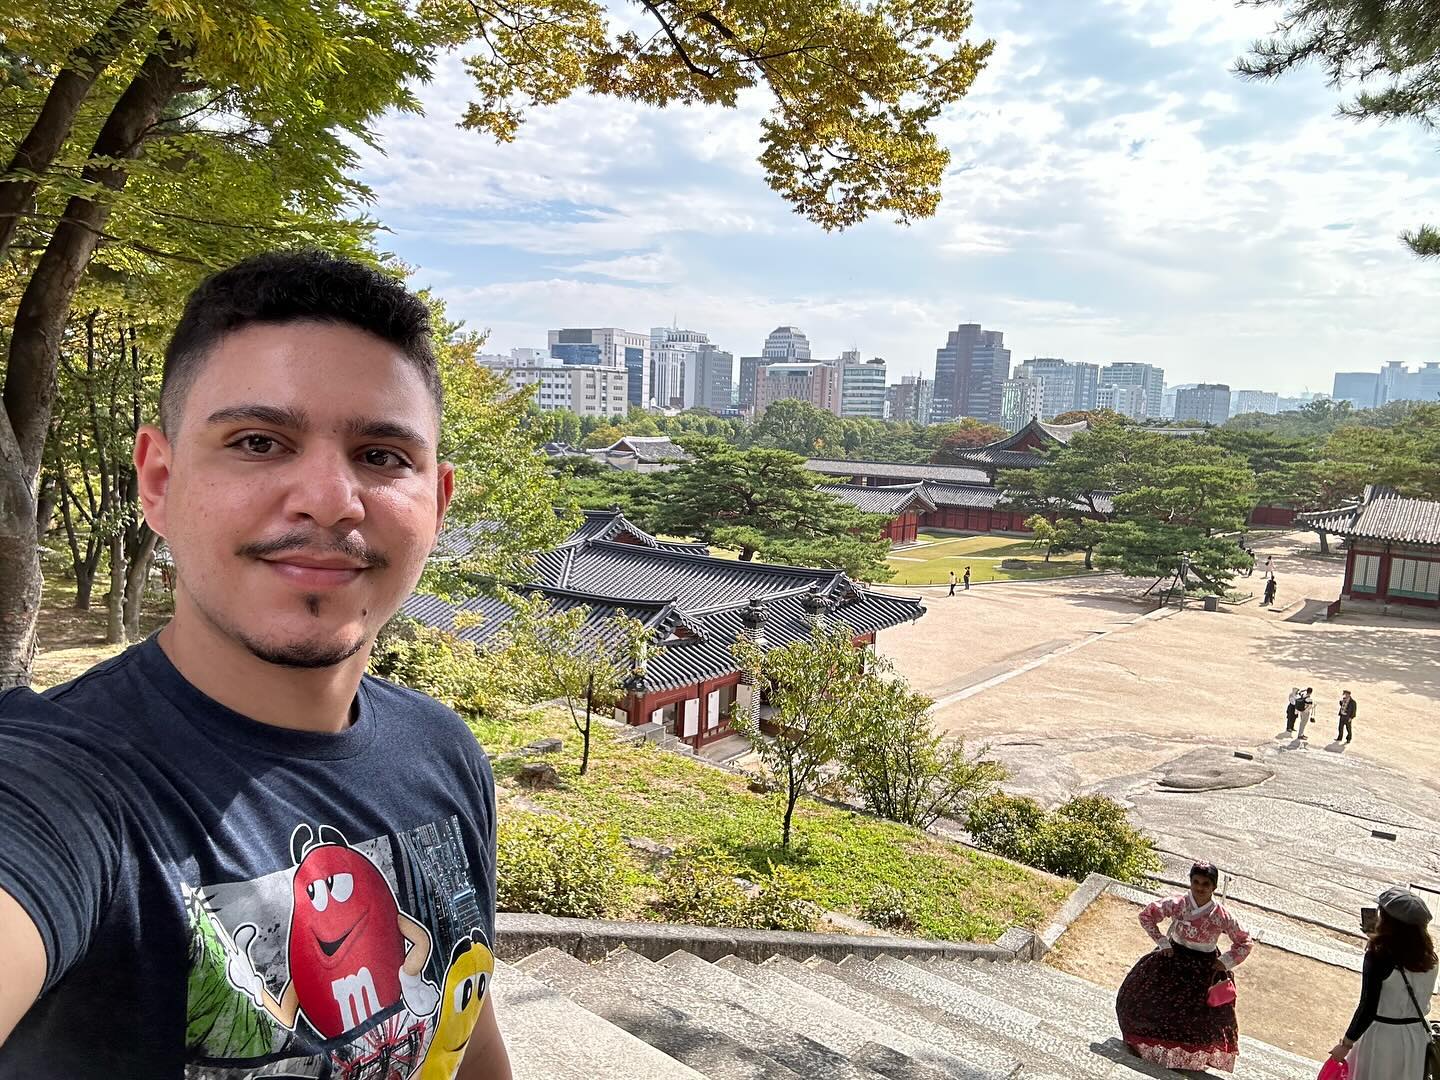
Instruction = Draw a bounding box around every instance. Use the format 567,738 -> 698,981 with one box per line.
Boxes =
160,249 -> 445,438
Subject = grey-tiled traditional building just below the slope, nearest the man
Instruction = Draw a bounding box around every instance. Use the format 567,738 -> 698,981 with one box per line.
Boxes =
400,511 -> 924,747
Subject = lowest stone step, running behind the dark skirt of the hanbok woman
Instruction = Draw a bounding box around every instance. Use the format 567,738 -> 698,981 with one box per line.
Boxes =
921,959 -> 1320,1080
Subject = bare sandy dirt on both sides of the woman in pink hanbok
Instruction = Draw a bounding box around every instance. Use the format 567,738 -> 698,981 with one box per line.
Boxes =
1045,896 -> 1359,1060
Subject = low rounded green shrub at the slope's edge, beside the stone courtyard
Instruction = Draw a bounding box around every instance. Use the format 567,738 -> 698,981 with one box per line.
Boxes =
968,793 -> 1161,884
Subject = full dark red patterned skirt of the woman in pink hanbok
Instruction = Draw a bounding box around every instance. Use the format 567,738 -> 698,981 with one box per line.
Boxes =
1115,945 -> 1240,1073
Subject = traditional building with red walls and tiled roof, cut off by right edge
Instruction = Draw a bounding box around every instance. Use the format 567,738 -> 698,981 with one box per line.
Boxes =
1296,485 -> 1440,619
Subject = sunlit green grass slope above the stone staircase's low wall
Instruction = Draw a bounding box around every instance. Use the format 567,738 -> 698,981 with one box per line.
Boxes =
495,733 -> 1071,942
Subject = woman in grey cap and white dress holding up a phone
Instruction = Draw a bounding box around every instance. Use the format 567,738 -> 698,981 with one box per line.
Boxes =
1331,886 -> 1436,1080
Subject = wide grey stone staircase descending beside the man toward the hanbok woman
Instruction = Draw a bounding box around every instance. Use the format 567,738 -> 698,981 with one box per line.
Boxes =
492,948 -> 1319,1080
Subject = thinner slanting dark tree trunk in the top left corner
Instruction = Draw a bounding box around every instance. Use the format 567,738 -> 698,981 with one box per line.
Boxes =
0,0 -> 145,262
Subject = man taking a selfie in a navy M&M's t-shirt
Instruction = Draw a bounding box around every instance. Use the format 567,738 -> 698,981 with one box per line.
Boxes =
0,252 -> 510,1080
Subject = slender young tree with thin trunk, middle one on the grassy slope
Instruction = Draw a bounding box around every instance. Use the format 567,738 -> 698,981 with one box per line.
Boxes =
732,626 -> 873,848
